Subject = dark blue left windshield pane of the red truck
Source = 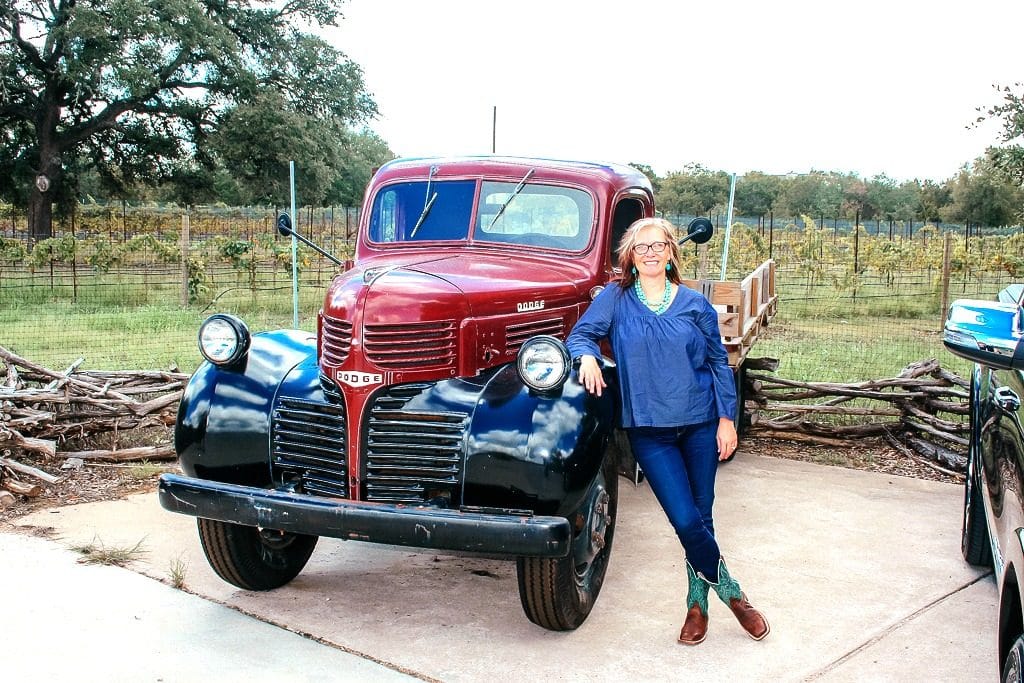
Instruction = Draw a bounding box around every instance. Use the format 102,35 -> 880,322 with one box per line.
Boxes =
370,180 -> 476,242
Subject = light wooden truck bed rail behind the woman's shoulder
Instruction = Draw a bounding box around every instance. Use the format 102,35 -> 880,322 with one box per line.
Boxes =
683,259 -> 778,368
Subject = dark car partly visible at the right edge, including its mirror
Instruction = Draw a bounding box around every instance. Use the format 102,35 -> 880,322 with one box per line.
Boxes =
943,285 -> 1024,681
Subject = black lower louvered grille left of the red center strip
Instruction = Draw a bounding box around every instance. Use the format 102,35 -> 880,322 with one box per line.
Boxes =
271,397 -> 348,498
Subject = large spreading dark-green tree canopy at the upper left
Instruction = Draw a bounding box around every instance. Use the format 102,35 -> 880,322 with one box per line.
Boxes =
0,0 -> 390,237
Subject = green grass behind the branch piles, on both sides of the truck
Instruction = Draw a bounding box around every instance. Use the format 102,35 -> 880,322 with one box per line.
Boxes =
0,259 -> 1009,382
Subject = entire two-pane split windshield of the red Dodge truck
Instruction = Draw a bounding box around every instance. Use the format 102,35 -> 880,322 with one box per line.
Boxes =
369,179 -> 594,251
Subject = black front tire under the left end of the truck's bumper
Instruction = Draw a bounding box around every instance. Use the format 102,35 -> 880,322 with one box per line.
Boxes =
198,517 -> 317,591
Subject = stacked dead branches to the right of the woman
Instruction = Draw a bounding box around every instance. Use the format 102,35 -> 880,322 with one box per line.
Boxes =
743,358 -> 970,474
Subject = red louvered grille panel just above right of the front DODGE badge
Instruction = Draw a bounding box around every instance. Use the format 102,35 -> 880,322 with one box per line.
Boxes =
364,321 -> 456,370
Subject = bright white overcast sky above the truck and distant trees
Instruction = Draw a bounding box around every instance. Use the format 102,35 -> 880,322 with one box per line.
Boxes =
328,0 -> 1024,180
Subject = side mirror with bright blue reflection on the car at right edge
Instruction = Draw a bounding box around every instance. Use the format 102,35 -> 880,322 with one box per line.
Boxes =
942,299 -> 1024,370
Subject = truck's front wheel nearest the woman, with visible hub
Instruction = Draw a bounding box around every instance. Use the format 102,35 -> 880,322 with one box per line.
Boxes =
516,453 -> 618,631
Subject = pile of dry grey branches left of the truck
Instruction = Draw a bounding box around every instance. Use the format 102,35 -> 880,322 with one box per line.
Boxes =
0,346 -> 188,496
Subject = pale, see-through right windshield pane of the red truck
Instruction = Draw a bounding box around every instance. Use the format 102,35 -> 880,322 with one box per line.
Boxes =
473,181 -> 594,251
